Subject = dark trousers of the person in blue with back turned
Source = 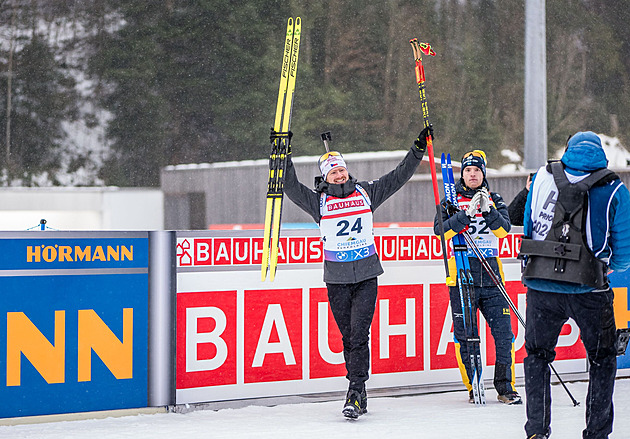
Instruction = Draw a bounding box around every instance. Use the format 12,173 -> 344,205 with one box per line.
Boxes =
524,288 -> 617,439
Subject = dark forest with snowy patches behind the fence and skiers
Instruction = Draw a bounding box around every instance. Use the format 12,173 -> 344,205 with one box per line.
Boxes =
0,0 -> 630,186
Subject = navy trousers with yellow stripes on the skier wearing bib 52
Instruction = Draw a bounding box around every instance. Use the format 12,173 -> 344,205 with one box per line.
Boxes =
449,286 -> 514,394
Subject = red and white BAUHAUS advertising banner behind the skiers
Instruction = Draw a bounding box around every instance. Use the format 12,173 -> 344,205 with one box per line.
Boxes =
176,228 -> 627,404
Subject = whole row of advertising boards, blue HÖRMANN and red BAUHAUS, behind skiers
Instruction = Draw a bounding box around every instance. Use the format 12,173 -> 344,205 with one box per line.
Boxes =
0,228 -> 630,418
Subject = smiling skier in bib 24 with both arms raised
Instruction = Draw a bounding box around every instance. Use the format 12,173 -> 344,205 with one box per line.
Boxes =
284,126 -> 433,418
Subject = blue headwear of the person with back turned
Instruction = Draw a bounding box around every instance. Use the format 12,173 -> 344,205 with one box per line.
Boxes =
562,131 -> 608,172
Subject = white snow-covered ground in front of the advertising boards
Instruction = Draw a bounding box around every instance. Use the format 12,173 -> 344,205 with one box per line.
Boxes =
0,378 -> 630,439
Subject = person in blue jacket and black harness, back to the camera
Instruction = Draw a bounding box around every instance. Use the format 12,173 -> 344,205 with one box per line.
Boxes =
521,131 -> 630,439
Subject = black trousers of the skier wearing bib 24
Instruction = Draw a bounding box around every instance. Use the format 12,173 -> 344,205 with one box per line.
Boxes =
326,277 -> 378,392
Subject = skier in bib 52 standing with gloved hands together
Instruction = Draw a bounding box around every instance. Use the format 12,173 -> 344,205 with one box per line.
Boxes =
434,150 -> 522,404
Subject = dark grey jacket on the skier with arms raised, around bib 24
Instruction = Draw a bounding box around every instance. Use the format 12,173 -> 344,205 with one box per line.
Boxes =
284,147 -> 422,284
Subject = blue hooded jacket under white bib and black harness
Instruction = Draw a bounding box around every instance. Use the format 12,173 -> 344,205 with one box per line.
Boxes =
523,131 -> 630,294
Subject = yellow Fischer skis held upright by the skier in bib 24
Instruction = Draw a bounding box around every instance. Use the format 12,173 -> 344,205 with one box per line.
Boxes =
261,17 -> 302,281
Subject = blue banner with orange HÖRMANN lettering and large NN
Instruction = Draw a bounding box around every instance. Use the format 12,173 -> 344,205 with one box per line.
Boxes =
0,231 -> 149,417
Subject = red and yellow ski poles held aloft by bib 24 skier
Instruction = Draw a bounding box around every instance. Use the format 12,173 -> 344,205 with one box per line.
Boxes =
409,38 -> 456,286
